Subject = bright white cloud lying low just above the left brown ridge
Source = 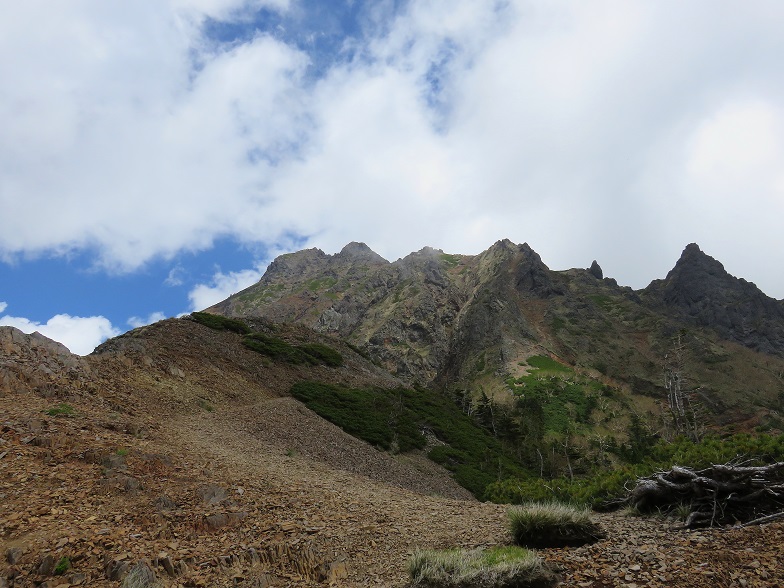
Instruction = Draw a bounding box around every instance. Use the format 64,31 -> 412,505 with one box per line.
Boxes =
0,310 -> 120,355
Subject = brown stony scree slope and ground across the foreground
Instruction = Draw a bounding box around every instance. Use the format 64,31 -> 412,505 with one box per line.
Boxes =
0,321 -> 784,588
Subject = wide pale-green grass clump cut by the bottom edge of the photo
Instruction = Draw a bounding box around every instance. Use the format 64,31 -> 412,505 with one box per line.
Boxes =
408,546 -> 559,588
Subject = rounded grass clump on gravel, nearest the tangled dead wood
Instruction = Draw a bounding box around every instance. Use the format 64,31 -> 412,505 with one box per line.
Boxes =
508,501 -> 605,547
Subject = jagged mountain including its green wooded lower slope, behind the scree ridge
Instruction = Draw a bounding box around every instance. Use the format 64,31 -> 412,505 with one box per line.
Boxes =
207,240 -> 784,500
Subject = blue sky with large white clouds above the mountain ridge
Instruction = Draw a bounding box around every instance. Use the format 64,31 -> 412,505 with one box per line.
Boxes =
0,0 -> 784,355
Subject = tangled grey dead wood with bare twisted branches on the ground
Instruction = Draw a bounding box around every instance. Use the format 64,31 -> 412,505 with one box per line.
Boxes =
626,462 -> 784,528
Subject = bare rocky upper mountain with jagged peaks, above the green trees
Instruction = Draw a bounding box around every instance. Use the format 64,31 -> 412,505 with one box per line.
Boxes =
208,240 -> 784,428
